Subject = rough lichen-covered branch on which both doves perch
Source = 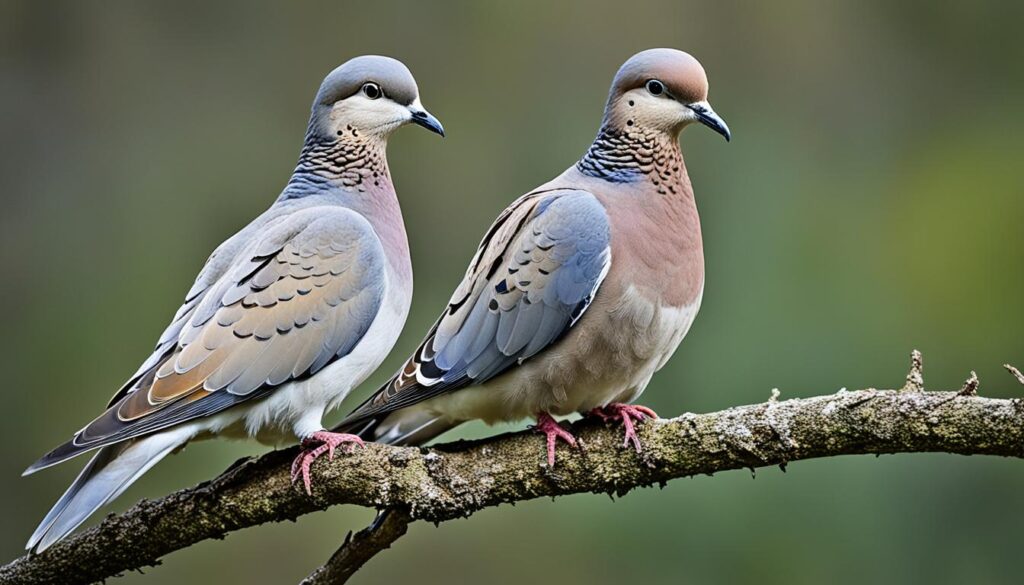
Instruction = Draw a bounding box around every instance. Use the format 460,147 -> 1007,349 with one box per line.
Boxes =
0,354 -> 1024,584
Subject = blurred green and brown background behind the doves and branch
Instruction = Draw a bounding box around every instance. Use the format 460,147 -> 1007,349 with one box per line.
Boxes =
0,0 -> 1024,585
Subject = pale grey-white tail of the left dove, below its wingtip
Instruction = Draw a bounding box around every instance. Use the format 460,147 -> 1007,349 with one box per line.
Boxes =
26,429 -> 191,552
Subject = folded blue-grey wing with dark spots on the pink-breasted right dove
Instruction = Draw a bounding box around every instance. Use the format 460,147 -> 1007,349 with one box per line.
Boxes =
341,190 -> 611,427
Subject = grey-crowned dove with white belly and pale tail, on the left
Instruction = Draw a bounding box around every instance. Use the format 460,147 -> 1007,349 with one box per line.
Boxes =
26,55 -> 444,552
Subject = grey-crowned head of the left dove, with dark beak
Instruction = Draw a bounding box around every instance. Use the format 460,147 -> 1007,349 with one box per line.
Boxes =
309,55 -> 444,140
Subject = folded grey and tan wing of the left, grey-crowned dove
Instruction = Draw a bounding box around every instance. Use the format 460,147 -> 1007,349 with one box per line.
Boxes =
30,207 -> 386,470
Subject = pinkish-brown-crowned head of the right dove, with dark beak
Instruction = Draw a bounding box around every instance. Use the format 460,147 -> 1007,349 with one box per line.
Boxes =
604,49 -> 731,140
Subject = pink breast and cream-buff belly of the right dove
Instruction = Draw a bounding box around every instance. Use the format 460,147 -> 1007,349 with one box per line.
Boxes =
395,169 -> 705,423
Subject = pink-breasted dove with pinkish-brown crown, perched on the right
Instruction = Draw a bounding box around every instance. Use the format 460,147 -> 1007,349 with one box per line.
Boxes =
338,49 -> 730,465
